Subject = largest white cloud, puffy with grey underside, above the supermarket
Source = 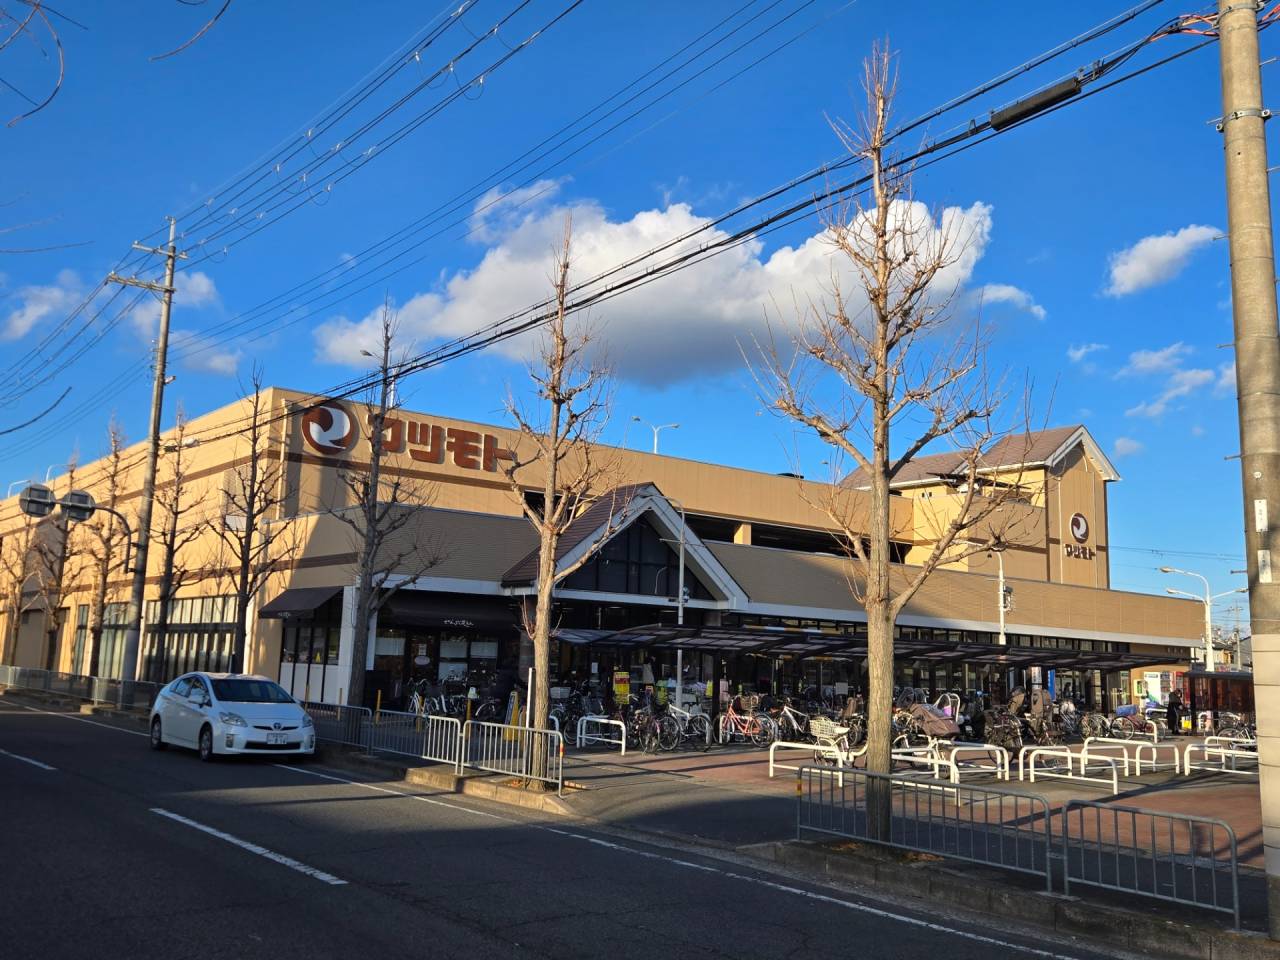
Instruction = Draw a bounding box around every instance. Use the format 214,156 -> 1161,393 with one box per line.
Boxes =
314,189 -> 998,384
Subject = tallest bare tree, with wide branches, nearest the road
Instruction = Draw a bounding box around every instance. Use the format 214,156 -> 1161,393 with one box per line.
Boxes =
759,46 -> 1025,826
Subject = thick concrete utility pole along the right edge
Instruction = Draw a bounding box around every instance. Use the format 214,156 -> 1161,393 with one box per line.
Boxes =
1217,0 -> 1280,940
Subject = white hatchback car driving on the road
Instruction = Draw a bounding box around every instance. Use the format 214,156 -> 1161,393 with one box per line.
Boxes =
151,673 -> 316,760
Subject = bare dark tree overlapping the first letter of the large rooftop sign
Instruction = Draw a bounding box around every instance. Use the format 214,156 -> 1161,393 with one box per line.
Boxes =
329,301 -> 439,707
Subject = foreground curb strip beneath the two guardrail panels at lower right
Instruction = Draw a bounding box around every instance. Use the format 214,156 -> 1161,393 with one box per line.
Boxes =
737,840 -> 1280,960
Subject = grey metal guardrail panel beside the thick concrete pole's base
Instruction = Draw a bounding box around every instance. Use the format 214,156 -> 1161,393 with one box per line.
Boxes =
1062,800 -> 1240,929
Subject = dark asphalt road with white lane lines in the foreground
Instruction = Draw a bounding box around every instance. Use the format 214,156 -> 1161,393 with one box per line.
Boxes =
0,701 -> 1121,960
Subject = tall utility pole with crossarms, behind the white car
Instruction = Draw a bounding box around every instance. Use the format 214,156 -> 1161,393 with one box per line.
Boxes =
108,216 -> 187,707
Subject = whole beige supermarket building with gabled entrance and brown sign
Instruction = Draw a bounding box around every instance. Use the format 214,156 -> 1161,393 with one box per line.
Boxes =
0,388 -> 1202,708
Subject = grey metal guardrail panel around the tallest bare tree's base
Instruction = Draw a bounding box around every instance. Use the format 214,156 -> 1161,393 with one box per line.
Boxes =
796,767 -> 1053,890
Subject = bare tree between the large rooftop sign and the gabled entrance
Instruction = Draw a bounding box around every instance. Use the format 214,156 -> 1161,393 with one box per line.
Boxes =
503,218 -> 627,752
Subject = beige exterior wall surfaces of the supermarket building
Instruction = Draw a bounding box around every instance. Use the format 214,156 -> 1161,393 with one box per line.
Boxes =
0,388 -> 1199,672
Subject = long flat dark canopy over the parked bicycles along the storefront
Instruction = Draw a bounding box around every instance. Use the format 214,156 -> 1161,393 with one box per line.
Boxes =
593,625 -> 1169,671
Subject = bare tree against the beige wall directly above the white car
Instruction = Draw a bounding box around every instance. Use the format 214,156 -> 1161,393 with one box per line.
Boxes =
212,369 -> 298,671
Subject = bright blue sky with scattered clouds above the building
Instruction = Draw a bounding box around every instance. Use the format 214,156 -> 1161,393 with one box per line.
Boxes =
0,0 -> 1259,632
